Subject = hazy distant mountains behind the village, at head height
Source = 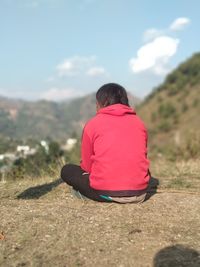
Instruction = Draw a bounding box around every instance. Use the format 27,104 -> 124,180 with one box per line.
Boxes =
0,94 -> 139,140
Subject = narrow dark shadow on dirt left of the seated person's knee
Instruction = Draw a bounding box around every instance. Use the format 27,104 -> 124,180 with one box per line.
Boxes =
17,179 -> 63,199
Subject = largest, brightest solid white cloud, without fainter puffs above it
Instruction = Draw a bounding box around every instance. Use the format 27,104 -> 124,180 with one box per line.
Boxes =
129,36 -> 180,75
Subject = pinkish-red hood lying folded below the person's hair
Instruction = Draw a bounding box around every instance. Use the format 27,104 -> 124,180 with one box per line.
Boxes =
97,104 -> 136,116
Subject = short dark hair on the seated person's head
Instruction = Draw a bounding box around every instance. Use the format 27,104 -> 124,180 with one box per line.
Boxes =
96,83 -> 129,107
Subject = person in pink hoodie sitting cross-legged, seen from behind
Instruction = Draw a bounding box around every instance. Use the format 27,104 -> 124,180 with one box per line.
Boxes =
61,83 -> 150,203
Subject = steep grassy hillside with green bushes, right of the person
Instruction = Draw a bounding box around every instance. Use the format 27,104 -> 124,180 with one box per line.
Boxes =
137,53 -> 200,159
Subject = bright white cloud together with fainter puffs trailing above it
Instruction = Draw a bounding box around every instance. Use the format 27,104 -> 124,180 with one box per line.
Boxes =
134,17 -> 190,75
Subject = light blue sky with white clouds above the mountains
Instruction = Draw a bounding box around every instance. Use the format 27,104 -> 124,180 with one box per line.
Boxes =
0,0 -> 200,101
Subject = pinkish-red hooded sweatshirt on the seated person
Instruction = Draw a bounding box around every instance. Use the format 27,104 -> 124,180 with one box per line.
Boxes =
81,104 -> 150,197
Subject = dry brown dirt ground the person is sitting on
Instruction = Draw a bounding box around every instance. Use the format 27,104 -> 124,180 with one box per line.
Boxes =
0,160 -> 200,267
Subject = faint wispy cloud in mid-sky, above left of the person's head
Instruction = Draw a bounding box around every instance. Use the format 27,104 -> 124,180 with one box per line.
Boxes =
56,56 -> 96,77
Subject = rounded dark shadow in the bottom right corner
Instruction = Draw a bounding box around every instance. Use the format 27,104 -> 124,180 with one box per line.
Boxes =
153,244 -> 200,267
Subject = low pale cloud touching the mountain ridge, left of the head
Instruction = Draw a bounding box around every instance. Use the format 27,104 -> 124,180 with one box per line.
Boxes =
40,87 -> 82,101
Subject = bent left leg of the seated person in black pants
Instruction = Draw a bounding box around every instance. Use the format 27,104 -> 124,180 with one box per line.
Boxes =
61,164 -> 111,202
